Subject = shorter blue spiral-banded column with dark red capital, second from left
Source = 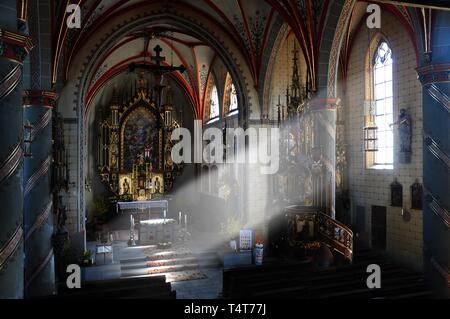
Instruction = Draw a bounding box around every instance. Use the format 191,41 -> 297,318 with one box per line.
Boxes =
23,91 -> 56,298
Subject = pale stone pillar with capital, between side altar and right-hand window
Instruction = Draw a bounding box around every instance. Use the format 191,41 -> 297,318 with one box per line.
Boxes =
310,99 -> 337,218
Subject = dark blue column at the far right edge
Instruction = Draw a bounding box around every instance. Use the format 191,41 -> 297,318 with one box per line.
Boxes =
418,11 -> 450,298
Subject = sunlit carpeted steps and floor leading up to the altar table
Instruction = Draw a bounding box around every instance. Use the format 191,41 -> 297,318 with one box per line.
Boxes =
83,230 -> 222,299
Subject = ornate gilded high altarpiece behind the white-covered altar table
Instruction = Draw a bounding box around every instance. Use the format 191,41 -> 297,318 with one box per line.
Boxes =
97,72 -> 182,200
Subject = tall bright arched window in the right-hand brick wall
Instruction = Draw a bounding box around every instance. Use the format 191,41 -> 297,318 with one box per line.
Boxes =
372,41 -> 394,169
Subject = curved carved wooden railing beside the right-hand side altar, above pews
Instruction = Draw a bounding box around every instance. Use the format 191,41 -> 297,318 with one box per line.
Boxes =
285,206 -> 353,261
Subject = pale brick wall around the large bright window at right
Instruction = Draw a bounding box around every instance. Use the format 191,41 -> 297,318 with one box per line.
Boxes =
344,12 -> 422,268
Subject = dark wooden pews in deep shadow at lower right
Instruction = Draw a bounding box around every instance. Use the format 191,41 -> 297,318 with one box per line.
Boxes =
222,251 -> 432,299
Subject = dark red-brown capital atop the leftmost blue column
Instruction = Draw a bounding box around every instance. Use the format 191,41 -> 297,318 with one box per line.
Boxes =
0,29 -> 34,64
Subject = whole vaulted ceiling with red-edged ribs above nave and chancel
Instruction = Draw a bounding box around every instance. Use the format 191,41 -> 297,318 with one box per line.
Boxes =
53,0 -> 426,119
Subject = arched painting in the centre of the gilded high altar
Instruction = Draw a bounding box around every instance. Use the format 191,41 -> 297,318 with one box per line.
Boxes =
122,107 -> 159,171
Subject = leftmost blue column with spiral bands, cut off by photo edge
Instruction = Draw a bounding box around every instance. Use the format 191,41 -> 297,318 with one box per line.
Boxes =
0,0 -> 32,299
